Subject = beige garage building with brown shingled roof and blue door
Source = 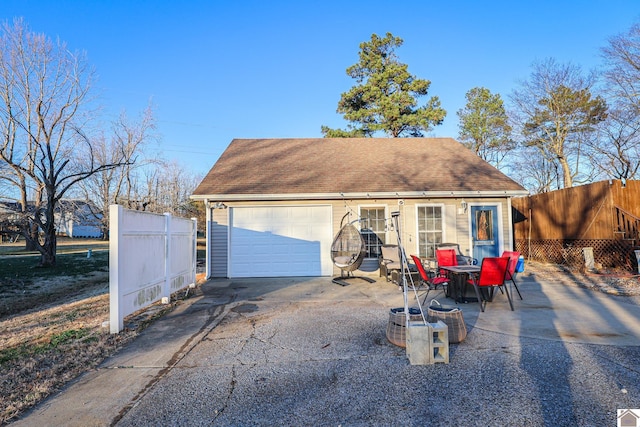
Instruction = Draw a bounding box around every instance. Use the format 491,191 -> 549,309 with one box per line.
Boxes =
191,138 -> 528,278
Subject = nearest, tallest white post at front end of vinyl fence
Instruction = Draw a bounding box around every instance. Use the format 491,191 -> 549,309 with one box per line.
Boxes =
109,205 -> 124,334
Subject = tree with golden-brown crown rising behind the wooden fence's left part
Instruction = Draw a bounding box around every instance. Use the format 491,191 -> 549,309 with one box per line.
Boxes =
512,59 -> 607,188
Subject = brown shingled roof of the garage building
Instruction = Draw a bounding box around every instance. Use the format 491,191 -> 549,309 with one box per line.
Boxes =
194,138 -> 526,197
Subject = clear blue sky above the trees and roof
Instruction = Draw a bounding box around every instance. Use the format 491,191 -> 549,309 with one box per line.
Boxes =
0,0 -> 640,174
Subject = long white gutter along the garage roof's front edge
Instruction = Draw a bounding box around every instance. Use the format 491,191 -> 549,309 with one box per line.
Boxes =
190,190 -> 529,202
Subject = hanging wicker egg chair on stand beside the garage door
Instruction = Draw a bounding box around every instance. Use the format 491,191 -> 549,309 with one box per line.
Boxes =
331,213 -> 375,286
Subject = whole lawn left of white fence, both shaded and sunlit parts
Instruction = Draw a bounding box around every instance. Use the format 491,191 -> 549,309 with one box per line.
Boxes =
0,241 -> 198,425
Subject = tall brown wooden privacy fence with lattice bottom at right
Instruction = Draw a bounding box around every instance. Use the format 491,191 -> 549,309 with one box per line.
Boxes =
512,180 -> 640,270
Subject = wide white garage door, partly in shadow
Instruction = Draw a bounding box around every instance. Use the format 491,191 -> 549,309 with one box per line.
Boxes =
229,206 -> 333,277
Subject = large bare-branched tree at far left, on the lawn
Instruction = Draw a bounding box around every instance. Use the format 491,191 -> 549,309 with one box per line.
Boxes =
0,20 -> 126,266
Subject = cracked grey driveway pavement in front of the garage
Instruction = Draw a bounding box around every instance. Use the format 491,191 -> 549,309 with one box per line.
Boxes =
15,272 -> 640,426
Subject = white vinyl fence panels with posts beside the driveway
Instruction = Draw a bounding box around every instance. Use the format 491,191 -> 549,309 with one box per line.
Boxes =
109,205 -> 197,334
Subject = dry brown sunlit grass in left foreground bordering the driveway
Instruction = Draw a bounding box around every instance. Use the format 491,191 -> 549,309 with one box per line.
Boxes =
0,280 -> 185,425
